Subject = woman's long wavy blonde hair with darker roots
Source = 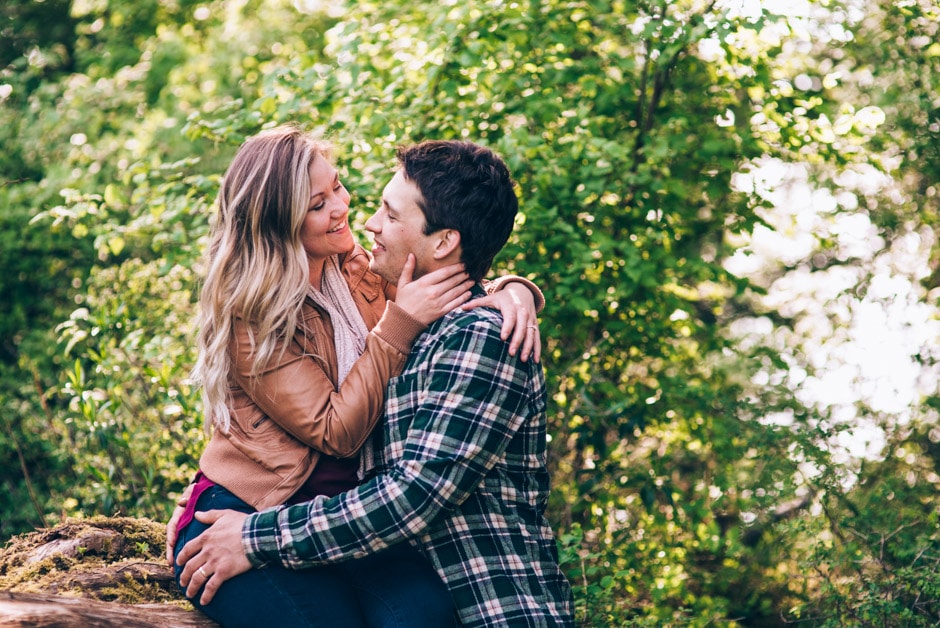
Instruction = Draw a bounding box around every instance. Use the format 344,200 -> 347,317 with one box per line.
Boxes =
193,126 -> 331,433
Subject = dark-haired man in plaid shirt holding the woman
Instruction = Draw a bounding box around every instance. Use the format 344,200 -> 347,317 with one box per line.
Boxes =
179,141 -> 574,626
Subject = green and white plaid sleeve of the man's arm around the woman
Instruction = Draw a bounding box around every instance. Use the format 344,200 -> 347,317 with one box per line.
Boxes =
242,310 -> 531,569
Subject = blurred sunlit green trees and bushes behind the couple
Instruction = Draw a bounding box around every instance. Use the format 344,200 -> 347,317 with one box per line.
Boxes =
0,0 -> 940,626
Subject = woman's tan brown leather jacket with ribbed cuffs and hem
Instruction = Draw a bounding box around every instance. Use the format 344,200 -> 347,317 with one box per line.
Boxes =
199,245 -> 544,510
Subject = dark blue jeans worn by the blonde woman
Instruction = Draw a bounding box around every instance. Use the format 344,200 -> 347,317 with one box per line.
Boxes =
176,486 -> 455,628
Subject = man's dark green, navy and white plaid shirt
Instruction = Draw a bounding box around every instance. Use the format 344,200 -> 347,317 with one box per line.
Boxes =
243,291 -> 574,626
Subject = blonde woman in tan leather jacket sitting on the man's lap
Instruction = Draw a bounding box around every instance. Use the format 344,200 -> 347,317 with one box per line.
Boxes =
168,127 -> 541,626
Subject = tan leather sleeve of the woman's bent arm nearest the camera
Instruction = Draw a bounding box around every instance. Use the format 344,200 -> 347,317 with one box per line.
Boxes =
233,302 -> 424,457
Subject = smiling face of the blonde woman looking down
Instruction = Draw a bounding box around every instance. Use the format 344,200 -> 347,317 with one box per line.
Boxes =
300,155 -> 353,262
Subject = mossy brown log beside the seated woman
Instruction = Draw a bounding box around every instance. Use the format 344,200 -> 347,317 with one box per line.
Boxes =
0,517 -> 216,628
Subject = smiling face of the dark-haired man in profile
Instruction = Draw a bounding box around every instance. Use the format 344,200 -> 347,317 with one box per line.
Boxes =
366,171 -> 436,284
